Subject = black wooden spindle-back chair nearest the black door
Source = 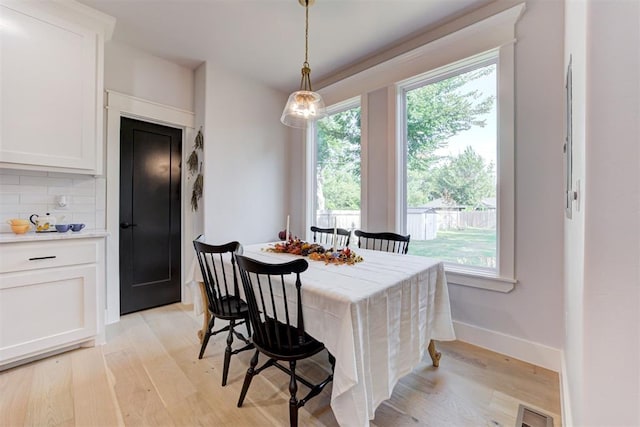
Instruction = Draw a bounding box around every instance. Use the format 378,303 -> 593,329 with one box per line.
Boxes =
193,236 -> 253,386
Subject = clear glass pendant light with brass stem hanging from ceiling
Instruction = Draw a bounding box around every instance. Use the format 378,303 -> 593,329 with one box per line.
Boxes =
280,0 -> 327,128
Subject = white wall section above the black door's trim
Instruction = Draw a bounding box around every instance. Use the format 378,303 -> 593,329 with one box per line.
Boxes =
104,40 -> 194,111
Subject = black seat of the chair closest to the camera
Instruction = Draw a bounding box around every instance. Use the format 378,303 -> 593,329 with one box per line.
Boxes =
253,320 -> 324,360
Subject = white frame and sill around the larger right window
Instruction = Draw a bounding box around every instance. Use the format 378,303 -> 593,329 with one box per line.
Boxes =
394,47 -> 517,292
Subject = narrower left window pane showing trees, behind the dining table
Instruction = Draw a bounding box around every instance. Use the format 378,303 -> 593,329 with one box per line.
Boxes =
315,106 -> 360,229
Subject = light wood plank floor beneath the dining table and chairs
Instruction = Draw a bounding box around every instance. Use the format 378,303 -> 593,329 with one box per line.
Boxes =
0,304 -> 560,427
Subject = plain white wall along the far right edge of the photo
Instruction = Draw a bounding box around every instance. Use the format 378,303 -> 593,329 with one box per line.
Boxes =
564,0 -> 640,426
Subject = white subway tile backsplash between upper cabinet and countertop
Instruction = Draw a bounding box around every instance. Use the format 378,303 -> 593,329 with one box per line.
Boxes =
0,168 -> 106,232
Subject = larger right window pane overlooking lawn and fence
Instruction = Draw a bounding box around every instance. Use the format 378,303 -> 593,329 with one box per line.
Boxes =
405,64 -> 497,269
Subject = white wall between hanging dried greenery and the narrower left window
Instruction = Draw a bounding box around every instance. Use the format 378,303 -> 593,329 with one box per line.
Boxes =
201,62 -> 293,244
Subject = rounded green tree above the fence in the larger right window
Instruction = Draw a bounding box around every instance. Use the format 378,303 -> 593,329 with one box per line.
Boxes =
432,147 -> 496,207
